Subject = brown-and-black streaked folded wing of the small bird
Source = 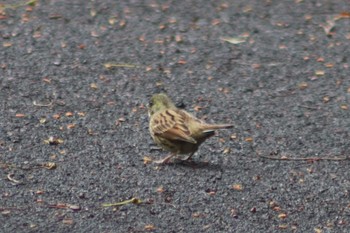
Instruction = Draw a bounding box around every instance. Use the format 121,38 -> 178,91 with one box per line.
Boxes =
151,109 -> 197,144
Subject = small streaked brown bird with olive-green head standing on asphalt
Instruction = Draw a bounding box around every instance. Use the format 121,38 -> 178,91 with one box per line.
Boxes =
148,94 -> 233,163
